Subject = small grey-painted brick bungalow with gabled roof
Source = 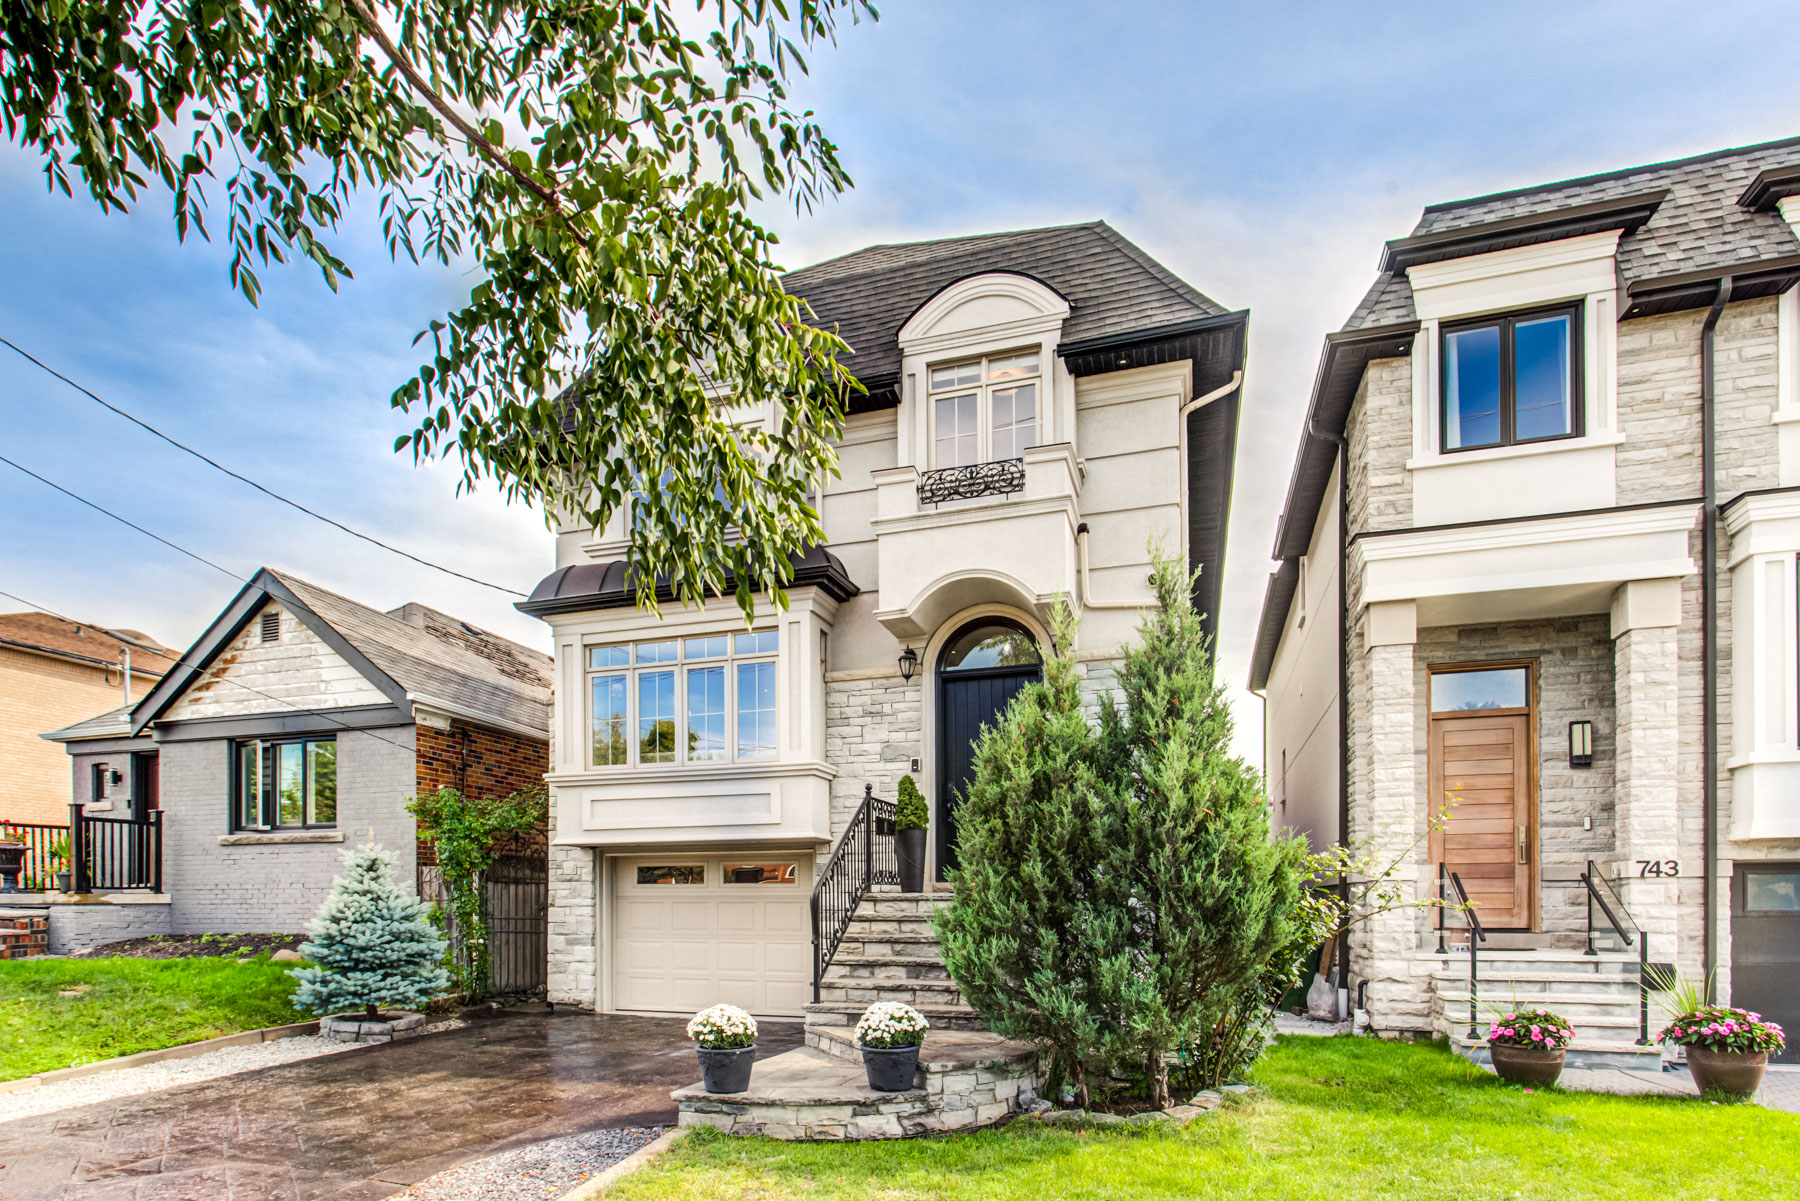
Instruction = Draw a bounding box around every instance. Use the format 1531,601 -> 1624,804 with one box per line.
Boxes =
40,569 -> 551,949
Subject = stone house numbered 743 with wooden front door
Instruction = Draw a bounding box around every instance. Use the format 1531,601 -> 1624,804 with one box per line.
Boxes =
1249,139 -> 1800,1061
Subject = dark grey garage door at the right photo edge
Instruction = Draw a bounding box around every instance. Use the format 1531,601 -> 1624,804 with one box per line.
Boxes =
1732,861 -> 1800,1064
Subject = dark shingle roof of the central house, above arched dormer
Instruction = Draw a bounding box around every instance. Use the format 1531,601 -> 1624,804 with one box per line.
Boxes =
783,221 -> 1226,385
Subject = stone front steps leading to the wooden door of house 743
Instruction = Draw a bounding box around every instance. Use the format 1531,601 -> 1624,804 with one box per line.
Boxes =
1429,944 -> 1661,1071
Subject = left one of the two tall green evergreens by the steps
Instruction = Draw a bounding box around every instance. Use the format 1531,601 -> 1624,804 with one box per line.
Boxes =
932,603 -> 1125,1106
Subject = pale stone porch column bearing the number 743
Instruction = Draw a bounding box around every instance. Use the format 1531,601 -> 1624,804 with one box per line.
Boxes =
1620,580 -> 1699,960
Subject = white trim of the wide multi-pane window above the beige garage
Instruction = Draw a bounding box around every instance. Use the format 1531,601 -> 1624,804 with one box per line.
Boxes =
580,625 -> 781,772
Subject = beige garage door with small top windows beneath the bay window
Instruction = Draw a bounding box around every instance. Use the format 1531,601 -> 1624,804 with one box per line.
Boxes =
612,852 -> 812,1017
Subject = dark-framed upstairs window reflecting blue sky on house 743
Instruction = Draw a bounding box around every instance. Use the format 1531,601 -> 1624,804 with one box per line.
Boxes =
1442,304 -> 1582,452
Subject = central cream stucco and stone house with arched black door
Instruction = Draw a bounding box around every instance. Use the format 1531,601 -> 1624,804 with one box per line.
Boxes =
518,221 -> 1247,1016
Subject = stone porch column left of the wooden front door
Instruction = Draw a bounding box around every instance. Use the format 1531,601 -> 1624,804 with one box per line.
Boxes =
1350,601 -> 1431,1030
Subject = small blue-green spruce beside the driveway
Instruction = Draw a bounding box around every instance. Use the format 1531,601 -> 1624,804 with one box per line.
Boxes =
288,839 -> 450,1019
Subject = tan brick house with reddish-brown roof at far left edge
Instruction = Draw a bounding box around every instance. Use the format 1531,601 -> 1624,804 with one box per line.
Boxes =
0,612 -> 175,825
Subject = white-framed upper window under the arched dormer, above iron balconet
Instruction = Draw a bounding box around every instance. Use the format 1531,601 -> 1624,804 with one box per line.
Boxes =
931,351 -> 1042,466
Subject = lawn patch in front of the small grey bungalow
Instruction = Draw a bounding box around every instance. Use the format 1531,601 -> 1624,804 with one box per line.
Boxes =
0,954 -> 304,1080
